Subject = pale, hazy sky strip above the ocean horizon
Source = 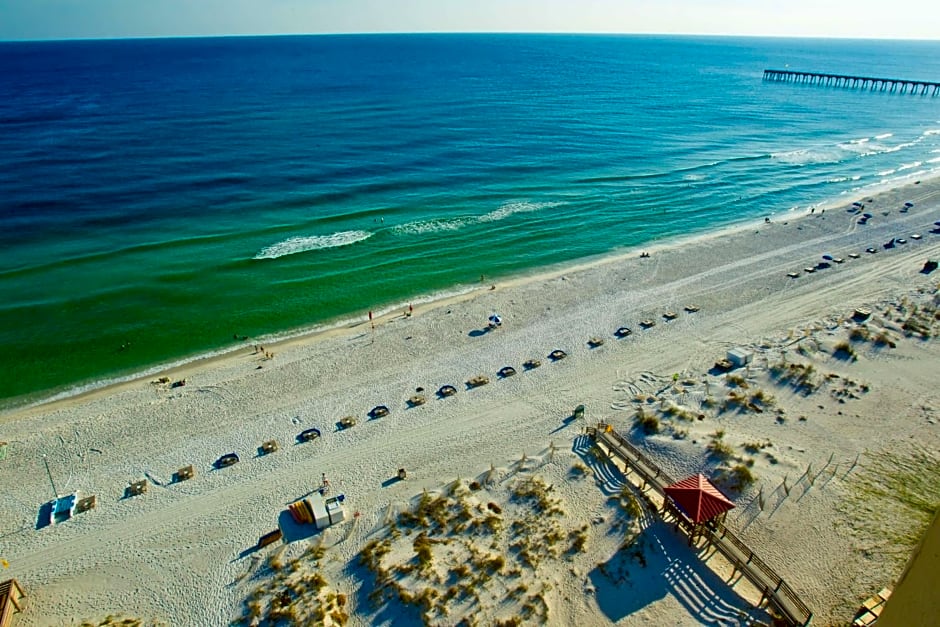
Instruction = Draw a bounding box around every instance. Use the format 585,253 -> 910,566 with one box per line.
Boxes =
0,0 -> 940,40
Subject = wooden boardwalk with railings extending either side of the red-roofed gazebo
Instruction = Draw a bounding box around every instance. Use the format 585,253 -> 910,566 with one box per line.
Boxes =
587,423 -> 813,626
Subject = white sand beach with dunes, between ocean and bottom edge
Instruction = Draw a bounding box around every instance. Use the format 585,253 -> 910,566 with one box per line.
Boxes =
0,180 -> 940,627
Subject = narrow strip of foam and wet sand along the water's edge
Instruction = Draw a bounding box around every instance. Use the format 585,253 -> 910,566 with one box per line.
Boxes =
0,172 -> 940,424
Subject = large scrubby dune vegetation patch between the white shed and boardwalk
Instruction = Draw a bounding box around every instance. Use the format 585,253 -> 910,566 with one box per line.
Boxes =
358,475 -> 640,625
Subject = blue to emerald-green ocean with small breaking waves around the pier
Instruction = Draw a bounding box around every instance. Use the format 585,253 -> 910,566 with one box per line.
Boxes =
0,34 -> 940,408
